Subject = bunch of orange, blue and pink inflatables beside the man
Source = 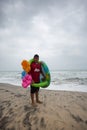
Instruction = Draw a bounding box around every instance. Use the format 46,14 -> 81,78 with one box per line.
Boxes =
21,60 -> 32,88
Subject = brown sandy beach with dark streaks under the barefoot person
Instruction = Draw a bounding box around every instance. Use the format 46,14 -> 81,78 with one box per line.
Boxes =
0,83 -> 87,130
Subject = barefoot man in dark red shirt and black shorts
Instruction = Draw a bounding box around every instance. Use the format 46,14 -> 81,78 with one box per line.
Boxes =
30,54 -> 45,106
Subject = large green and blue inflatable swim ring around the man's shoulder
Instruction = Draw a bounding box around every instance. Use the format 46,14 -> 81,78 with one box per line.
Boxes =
29,59 -> 51,88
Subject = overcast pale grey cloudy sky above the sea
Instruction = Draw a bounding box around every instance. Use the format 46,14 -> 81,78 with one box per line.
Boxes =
0,0 -> 87,71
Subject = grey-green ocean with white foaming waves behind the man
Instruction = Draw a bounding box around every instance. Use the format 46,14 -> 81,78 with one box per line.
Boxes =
0,70 -> 87,92
